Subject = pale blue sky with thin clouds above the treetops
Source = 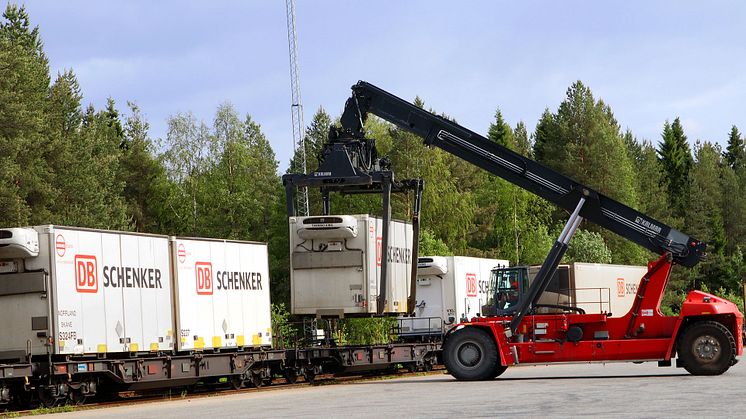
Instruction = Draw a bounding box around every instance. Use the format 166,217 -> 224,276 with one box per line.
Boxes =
18,0 -> 746,172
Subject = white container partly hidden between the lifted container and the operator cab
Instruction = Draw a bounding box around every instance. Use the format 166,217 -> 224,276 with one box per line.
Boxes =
402,256 -> 508,329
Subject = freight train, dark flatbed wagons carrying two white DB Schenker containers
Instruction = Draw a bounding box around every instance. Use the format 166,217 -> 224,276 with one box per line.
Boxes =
0,225 -> 440,406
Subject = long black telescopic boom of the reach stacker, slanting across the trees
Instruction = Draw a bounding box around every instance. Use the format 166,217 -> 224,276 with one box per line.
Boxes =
338,81 -> 706,267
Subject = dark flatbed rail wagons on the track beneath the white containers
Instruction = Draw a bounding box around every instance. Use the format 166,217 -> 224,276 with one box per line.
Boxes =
0,340 -> 441,408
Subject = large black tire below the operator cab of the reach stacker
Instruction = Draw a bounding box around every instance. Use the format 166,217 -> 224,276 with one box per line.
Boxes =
443,327 -> 505,381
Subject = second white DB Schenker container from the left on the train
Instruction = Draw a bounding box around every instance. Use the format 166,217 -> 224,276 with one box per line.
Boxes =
172,238 -> 272,351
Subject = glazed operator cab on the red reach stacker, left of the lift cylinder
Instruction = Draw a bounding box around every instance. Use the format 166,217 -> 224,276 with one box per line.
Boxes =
482,266 -> 528,316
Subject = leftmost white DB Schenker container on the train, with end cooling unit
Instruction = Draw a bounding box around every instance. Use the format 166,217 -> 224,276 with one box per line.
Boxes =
0,225 -> 173,354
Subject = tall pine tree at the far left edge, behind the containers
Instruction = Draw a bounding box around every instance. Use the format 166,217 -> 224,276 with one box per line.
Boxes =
0,4 -> 54,225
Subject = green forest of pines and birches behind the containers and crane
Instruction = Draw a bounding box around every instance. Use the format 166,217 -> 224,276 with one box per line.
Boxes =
0,4 -> 746,313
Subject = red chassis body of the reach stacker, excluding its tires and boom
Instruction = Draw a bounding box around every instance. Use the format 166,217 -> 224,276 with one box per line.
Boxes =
452,255 -> 743,366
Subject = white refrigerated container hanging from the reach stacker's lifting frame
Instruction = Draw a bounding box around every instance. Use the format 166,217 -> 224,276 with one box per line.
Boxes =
290,214 -> 412,316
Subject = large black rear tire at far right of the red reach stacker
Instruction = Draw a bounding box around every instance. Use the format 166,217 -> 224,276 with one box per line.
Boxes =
678,321 -> 736,375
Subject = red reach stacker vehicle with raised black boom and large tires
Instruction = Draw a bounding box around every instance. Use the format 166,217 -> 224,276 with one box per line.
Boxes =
314,81 -> 743,380
